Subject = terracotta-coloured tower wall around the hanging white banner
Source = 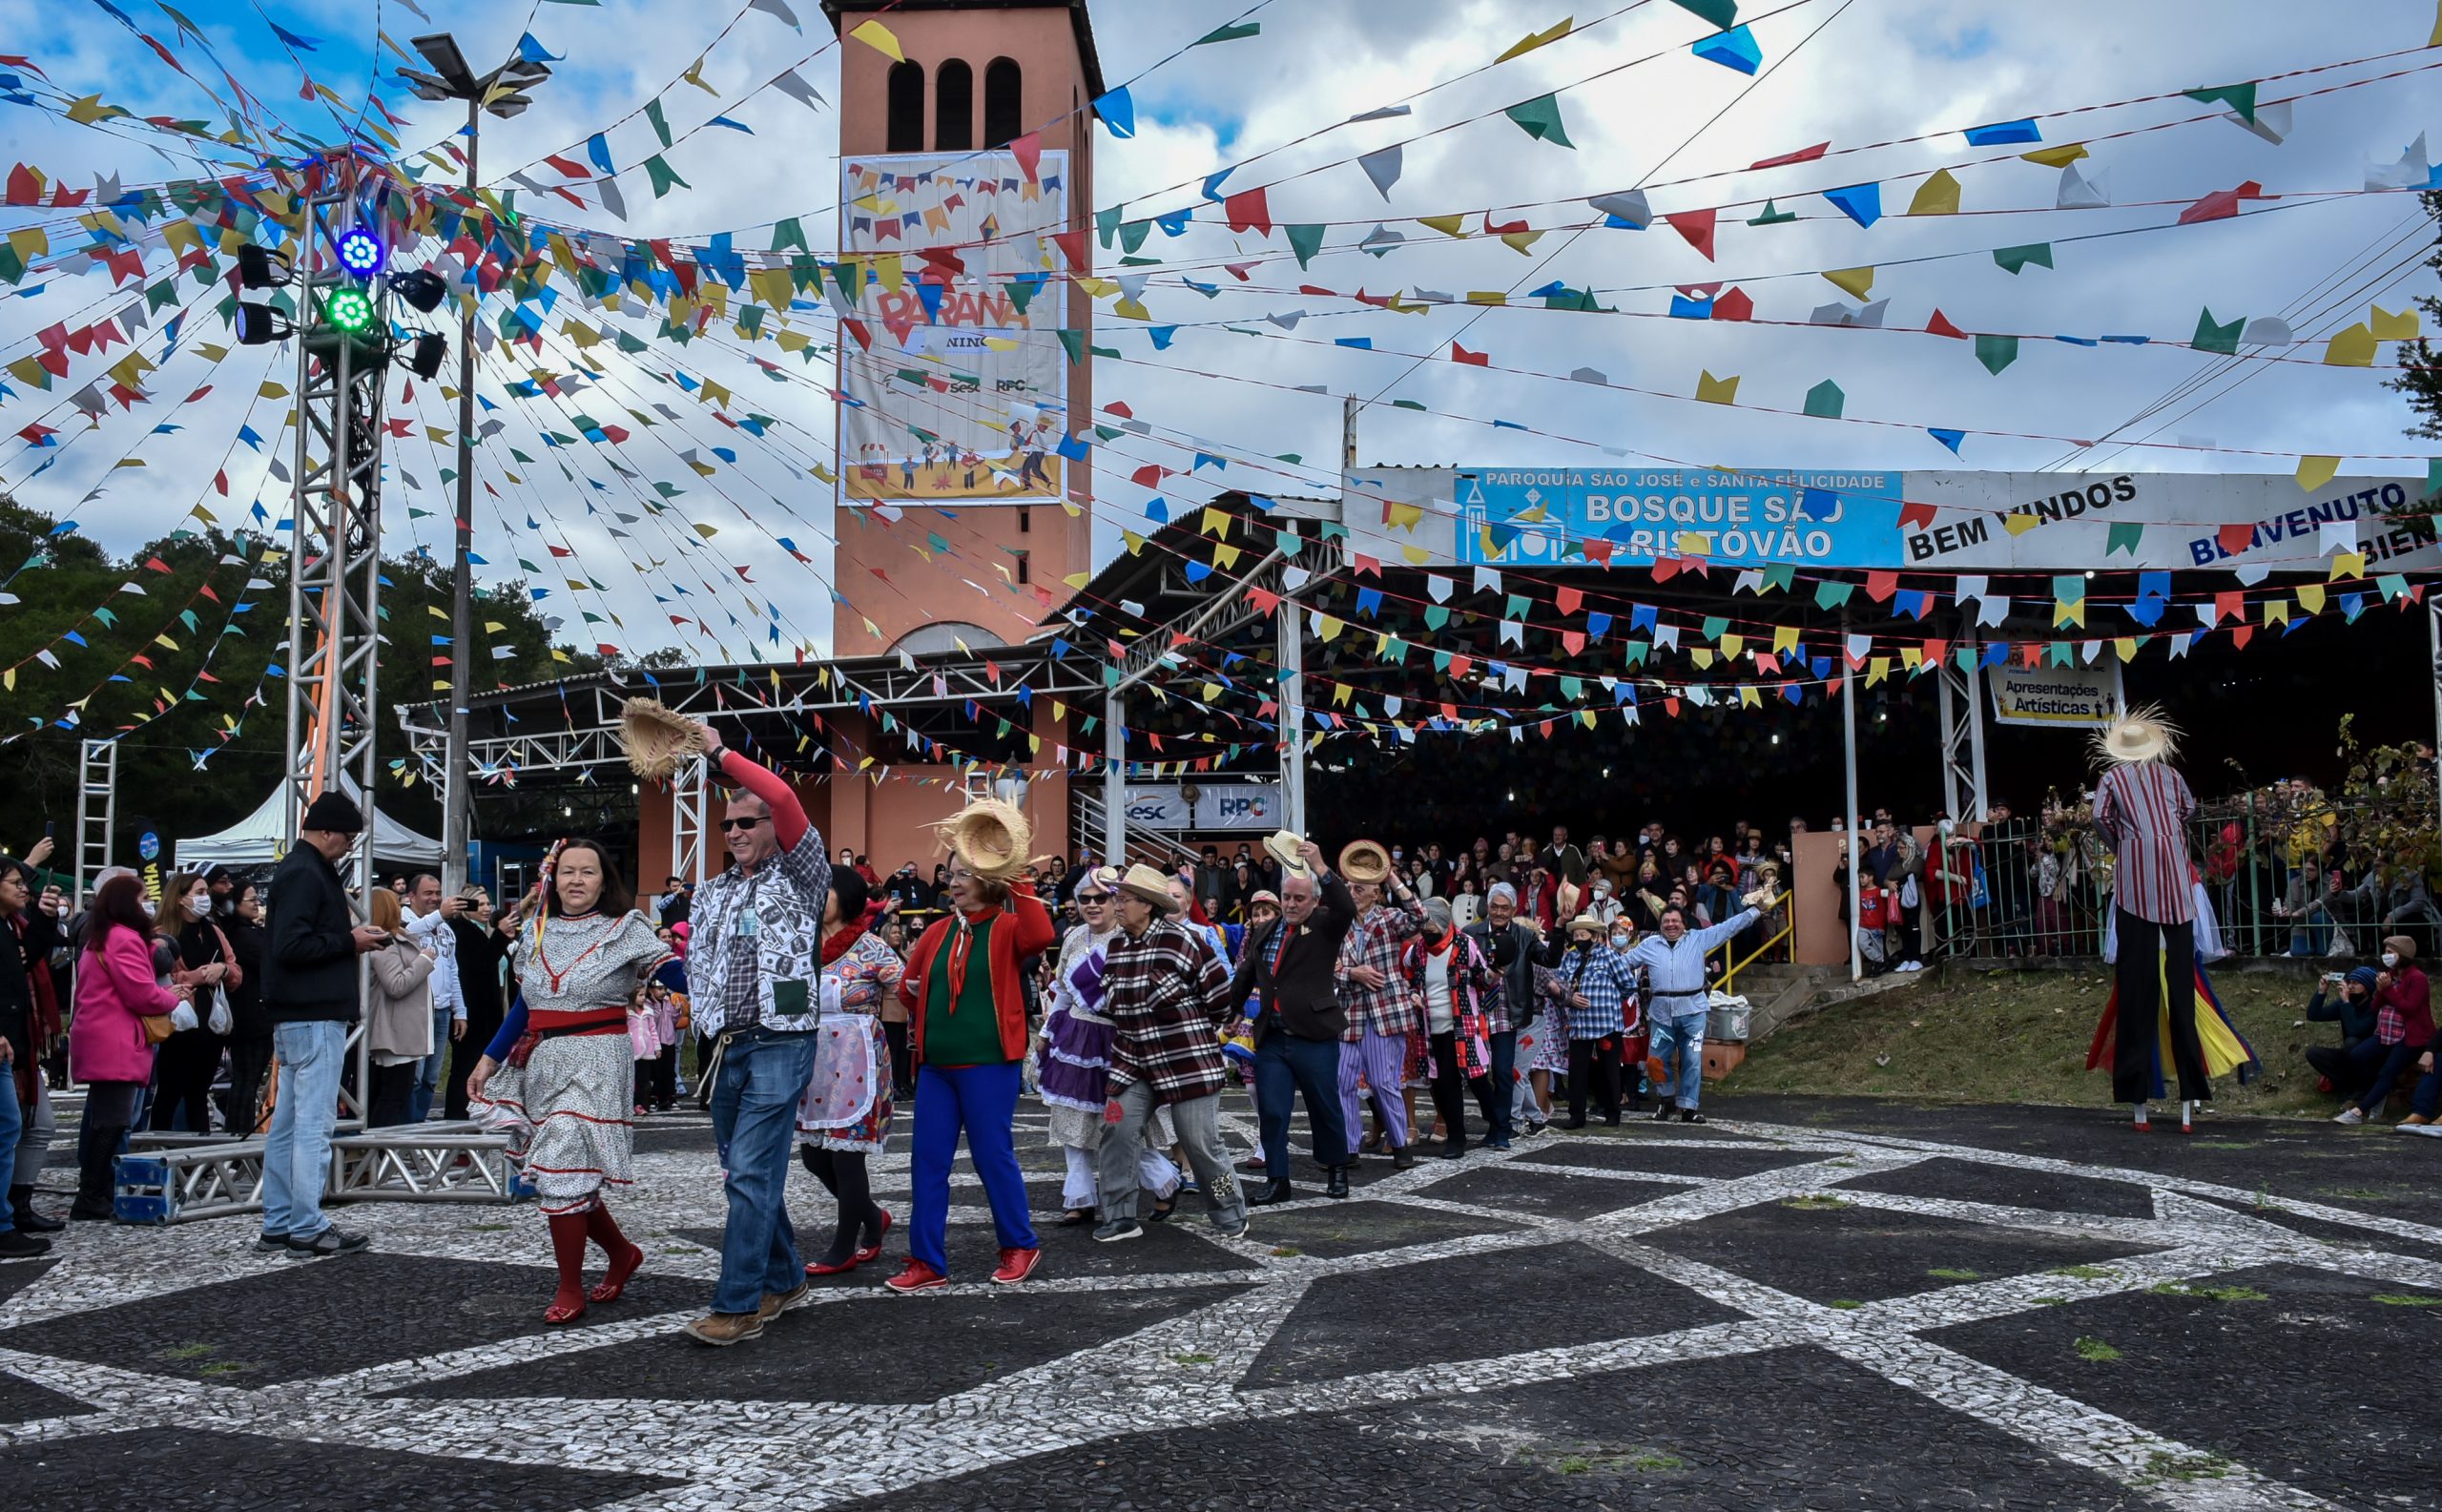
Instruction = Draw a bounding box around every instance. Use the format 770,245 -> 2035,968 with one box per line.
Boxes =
833,5 -> 1094,657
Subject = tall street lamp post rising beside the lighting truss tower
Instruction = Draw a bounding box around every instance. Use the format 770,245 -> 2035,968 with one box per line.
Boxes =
398,31 -> 552,897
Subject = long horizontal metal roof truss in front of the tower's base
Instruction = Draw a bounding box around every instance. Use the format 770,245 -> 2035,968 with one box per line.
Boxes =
396,645 -> 1102,781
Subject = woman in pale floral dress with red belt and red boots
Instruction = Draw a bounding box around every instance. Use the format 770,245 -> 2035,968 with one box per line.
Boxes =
466,840 -> 669,1324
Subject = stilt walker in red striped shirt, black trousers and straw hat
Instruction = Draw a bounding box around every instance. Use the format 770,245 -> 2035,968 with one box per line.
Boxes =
2095,709 -> 2212,1131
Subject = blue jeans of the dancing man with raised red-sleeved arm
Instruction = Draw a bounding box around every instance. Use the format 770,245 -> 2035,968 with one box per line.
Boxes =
714,1028 -> 813,1312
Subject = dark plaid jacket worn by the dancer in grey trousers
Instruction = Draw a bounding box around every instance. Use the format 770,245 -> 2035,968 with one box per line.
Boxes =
1102,919 -> 1238,1104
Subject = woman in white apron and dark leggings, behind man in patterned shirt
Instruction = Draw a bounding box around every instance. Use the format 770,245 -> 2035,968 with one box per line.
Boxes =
797,867 -> 906,1275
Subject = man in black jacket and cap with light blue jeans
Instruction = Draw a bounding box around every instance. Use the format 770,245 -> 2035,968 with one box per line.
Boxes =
254,792 -> 388,1260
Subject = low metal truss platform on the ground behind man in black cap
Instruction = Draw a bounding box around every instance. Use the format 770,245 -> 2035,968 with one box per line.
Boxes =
114,1124 -> 507,1224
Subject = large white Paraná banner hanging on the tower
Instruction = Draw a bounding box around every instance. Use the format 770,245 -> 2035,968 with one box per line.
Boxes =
830,152 -> 1069,503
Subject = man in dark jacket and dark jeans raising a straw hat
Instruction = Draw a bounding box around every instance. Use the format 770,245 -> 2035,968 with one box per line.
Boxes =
1229,831 -> 1367,1207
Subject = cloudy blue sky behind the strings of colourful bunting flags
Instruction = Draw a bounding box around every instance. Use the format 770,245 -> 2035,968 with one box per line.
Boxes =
0,0 -> 2442,673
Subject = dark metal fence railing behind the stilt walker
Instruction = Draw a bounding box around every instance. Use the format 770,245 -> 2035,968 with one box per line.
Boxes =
1919,794 -> 2442,958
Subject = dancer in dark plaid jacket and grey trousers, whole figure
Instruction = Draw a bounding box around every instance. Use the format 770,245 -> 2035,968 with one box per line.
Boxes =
1094,864 -> 1246,1243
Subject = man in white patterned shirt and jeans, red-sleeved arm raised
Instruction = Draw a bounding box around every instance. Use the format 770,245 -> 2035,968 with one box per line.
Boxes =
686,725 -> 830,1343
